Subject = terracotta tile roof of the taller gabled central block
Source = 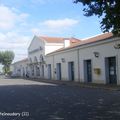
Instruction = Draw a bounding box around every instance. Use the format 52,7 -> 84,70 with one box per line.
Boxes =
39,36 -> 80,44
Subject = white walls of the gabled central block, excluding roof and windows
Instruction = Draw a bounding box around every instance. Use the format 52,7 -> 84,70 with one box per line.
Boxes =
28,36 -> 63,78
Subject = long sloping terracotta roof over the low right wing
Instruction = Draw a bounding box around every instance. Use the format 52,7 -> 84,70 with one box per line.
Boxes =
46,33 -> 113,54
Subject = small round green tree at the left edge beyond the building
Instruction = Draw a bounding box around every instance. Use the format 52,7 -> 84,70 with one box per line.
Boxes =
0,51 -> 14,74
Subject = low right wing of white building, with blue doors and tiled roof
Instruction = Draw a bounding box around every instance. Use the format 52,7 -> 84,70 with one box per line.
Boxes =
46,35 -> 120,84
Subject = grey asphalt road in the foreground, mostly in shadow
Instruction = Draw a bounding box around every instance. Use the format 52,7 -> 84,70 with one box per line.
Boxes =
0,78 -> 120,120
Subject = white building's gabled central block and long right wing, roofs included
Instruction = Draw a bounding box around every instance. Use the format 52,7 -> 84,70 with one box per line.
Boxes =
13,33 -> 120,85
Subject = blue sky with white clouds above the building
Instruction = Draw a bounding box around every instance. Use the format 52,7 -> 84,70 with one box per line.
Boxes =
0,0 -> 102,62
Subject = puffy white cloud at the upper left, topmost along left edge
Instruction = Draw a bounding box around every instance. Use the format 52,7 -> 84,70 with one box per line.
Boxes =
0,5 -> 29,30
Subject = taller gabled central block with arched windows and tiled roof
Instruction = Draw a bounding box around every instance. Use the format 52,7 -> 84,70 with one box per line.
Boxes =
28,36 -> 79,78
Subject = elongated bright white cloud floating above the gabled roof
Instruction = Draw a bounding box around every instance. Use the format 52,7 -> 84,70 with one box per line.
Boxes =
42,18 -> 79,29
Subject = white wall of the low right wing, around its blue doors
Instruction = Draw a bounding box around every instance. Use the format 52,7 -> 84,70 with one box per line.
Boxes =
46,37 -> 120,84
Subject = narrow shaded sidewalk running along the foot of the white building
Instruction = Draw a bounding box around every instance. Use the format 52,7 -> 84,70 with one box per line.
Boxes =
25,78 -> 120,91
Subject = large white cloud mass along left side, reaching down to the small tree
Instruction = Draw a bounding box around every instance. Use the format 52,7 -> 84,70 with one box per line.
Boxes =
0,5 -> 31,61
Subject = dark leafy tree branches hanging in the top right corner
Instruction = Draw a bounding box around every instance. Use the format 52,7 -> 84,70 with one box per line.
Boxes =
74,0 -> 120,36
